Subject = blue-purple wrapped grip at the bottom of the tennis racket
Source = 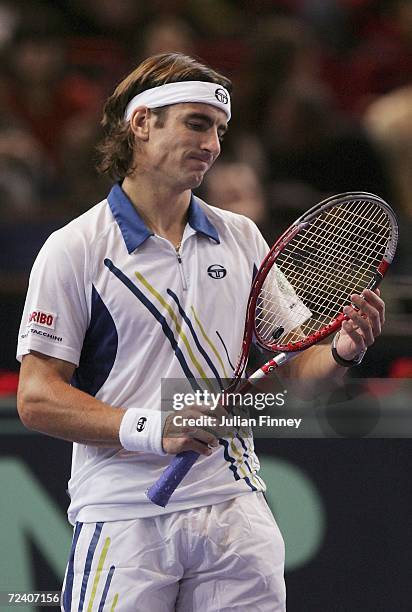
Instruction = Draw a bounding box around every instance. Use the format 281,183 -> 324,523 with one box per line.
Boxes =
146,451 -> 199,508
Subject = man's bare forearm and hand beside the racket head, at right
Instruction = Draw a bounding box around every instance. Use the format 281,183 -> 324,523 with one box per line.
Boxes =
282,289 -> 385,380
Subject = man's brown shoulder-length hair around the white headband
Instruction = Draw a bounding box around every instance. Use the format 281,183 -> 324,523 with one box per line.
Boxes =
97,53 -> 232,180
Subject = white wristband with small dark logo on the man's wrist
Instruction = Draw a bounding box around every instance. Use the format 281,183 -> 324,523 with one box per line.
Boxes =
119,408 -> 167,455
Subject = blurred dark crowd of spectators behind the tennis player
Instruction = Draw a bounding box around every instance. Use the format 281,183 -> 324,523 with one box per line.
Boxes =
0,0 -> 412,376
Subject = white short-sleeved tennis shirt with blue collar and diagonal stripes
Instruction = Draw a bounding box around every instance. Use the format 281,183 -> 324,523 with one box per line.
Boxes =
17,185 -> 302,524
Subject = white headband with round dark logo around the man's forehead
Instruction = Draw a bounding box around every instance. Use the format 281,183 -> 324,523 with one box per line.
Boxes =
124,81 -> 230,121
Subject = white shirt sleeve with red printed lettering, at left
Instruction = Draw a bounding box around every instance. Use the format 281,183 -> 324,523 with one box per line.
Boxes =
17,230 -> 91,366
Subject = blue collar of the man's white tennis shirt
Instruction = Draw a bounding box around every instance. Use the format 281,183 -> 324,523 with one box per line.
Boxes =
107,183 -> 220,253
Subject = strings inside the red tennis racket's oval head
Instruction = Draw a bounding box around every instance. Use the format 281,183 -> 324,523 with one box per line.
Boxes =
255,200 -> 391,345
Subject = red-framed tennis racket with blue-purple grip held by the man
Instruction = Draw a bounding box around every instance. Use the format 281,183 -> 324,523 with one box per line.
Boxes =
147,192 -> 398,507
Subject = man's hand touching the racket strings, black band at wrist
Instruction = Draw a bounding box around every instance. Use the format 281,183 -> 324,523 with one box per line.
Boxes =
336,289 -> 385,361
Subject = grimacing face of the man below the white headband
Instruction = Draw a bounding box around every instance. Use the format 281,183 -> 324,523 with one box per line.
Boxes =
138,103 -> 227,191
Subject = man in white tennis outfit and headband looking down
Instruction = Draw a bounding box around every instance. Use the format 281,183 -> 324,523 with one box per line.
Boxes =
18,54 -> 384,612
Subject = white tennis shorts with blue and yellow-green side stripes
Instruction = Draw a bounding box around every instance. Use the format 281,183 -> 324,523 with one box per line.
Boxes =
62,493 -> 286,612
